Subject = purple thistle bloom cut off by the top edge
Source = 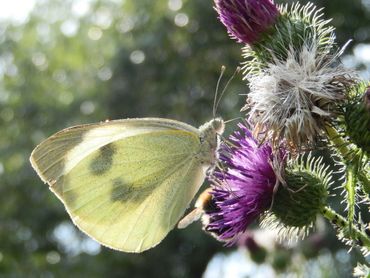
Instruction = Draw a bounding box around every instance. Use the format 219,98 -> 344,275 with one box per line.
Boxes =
214,0 -> 280,44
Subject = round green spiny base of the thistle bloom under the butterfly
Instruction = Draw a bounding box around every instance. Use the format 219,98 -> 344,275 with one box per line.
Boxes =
262,155 -> 331,237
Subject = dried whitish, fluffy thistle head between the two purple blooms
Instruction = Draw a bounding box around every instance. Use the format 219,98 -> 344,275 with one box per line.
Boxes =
244,44 -> 354,150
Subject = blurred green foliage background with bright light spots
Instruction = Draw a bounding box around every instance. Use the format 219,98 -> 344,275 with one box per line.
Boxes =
0,0 -> 370,277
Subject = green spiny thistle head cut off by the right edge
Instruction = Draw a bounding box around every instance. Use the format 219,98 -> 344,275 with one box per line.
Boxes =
343,82 -> 370,155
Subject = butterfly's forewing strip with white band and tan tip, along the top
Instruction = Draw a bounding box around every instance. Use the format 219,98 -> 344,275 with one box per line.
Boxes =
30,118 -> 198,183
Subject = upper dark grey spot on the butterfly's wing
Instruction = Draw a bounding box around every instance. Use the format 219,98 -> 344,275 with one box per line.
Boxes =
90,143 -> 116,176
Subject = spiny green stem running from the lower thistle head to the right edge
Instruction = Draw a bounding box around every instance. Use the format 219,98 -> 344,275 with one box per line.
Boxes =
321,206 -> 370,252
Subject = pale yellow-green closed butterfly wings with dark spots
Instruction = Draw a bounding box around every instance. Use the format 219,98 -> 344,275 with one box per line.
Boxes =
31,118 -> 205,252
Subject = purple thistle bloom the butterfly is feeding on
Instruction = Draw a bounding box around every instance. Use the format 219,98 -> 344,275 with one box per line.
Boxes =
204,124 -> 277,244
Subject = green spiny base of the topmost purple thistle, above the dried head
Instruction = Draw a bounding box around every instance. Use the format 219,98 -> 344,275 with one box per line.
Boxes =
243,3 -> 335,78
